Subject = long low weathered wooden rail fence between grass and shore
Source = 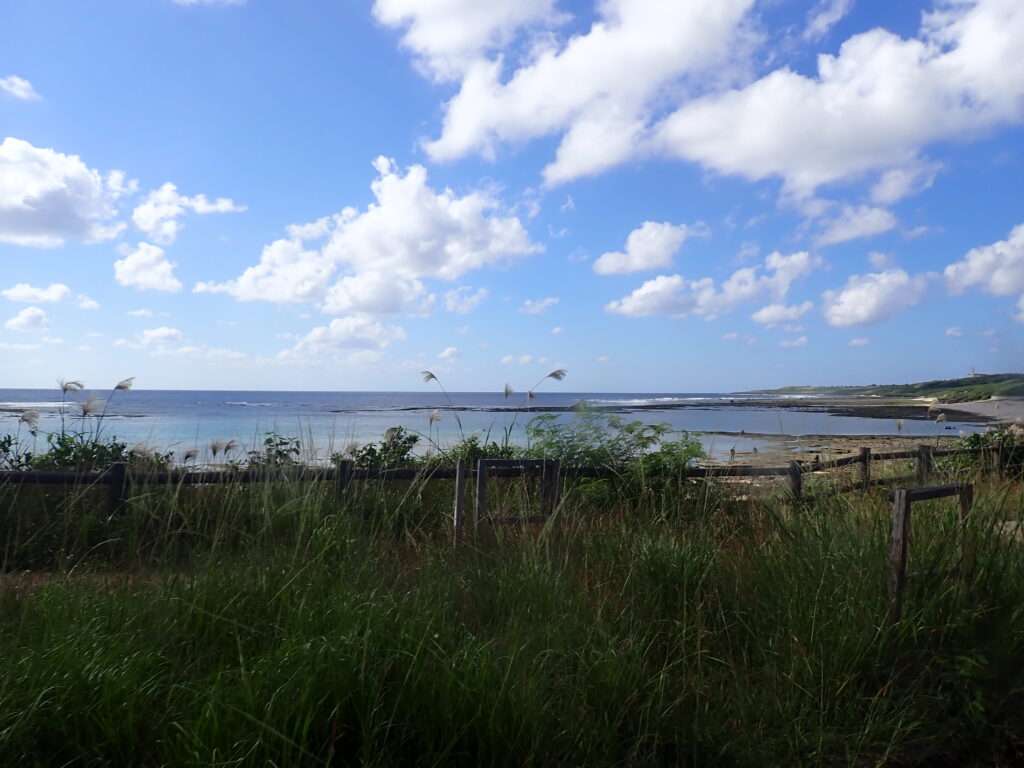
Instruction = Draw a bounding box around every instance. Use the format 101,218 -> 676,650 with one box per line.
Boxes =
0,444 -> 1010,519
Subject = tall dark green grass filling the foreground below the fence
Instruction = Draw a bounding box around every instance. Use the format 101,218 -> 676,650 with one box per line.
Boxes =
0,473 -> 1024,766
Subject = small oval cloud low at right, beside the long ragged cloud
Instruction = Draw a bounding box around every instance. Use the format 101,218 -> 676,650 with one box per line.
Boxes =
822,269 -> 928,328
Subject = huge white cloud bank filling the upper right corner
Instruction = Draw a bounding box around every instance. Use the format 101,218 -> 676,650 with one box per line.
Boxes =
652,0 -> 1024,199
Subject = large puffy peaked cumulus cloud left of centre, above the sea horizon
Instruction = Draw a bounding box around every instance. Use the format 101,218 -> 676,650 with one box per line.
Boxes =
196,158 -> 542,313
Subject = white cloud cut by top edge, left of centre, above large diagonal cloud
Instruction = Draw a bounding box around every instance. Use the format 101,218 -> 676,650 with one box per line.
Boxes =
374,0 -> 561,80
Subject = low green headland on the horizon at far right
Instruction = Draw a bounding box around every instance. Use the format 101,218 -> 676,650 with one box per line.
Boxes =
742,374 -> 1024,402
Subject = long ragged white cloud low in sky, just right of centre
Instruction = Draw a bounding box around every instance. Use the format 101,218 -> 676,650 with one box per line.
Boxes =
604,251 -> 823,319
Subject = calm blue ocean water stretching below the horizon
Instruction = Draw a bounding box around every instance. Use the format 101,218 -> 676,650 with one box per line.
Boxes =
0,389 -> 984,459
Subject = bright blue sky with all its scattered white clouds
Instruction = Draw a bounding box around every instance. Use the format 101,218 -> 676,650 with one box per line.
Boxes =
0,0 -> 1024,392
